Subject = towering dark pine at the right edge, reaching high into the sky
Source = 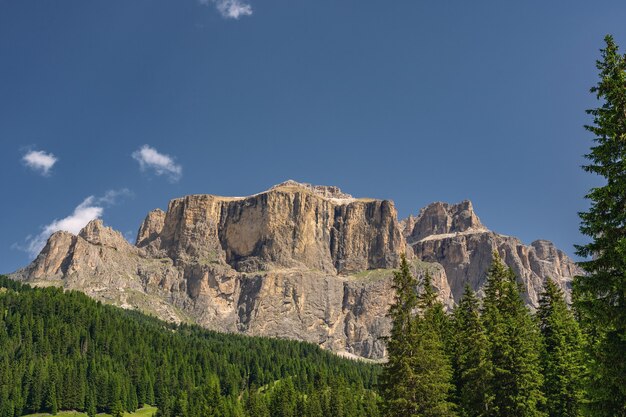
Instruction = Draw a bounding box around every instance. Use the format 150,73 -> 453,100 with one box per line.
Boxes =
574,36 -> 626,416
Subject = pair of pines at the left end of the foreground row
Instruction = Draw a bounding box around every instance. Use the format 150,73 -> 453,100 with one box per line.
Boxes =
382,257 -> 454,417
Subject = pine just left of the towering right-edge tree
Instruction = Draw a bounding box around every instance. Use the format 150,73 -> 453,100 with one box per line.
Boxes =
537,278 -> 584,417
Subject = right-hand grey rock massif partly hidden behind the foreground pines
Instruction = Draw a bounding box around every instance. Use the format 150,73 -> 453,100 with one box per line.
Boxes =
404,201 -> 582,307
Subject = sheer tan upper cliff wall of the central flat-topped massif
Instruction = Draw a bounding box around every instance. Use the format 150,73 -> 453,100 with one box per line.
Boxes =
137,182 -> 405,274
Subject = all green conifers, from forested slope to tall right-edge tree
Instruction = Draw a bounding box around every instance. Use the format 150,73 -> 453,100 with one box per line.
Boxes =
0,36 -> 626,417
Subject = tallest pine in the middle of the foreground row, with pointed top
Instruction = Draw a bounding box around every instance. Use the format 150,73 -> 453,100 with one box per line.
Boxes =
482,252 -> 545,417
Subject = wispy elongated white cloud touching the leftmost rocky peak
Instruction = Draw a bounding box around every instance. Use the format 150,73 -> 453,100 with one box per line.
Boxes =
13,188 -> 132,258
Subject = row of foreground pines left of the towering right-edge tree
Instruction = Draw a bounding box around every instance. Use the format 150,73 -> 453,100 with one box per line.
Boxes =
381,253 -> 585,417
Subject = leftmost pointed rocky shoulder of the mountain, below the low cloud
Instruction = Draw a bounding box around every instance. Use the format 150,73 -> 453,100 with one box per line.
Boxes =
11,220 -> 187,322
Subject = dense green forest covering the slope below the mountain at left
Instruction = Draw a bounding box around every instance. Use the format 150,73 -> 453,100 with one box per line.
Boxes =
0,276 -> 379,417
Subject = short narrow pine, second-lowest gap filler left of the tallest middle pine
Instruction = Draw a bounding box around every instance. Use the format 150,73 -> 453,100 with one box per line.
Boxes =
453,285 -> 492,417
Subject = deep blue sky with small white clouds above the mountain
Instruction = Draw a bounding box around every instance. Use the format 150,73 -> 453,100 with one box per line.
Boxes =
0,0 -> 626,272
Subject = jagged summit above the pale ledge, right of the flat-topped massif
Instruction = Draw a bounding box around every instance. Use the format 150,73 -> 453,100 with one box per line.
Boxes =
404,200 -> 487,243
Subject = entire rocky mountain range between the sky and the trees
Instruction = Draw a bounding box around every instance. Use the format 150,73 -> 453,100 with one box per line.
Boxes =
11,181 -> 579,359
